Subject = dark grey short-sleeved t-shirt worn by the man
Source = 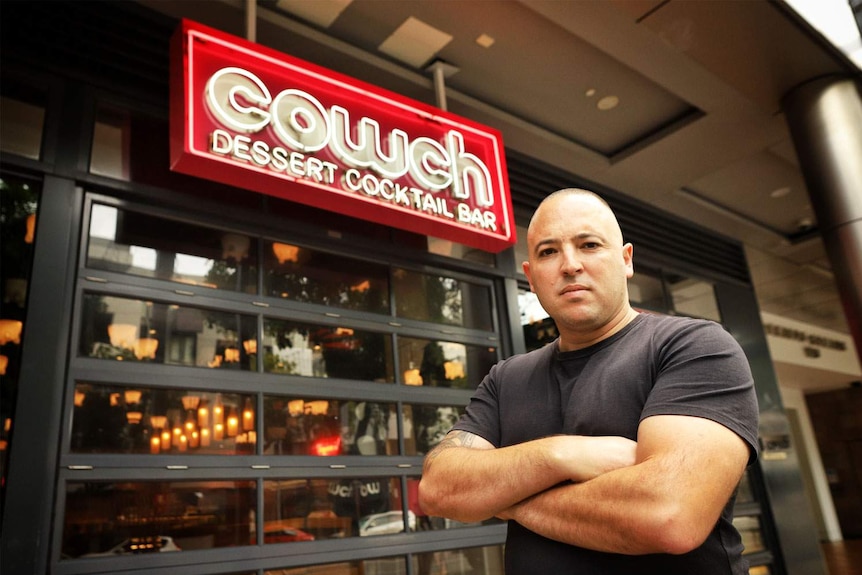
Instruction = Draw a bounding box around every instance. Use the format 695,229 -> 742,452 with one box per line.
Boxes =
454,314 -> 758,575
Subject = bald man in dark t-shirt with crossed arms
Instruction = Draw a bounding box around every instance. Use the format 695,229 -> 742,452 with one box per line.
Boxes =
419,189 -> 757,575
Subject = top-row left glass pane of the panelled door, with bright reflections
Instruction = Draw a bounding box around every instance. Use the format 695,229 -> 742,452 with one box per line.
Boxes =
87,204 -> 257,294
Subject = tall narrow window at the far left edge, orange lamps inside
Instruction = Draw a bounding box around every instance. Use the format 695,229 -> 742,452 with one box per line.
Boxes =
0,174 -> 41,508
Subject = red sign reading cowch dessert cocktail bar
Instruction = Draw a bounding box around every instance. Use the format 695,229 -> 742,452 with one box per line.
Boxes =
171,20 -> 515,252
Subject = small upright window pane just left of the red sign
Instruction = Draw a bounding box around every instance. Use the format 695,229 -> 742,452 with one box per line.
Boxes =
90,106 -> 131,180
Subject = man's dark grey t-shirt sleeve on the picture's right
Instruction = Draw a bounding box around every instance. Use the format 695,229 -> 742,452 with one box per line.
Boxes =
641,321 -> 759,463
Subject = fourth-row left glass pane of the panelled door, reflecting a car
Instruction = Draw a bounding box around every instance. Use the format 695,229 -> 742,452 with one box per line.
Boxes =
62,481 -> 257,558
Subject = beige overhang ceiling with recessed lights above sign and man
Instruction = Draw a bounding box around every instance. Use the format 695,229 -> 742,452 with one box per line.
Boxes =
141,0 -> 859,390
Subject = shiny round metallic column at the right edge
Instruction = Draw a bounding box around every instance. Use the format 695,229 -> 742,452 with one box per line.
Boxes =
783,76 -> 862,361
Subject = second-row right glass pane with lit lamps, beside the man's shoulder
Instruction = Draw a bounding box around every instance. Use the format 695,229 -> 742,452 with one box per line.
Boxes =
398,337 -> 497,389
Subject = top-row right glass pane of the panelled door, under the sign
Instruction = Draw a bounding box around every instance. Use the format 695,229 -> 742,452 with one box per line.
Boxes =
393,269 -> 494,330
